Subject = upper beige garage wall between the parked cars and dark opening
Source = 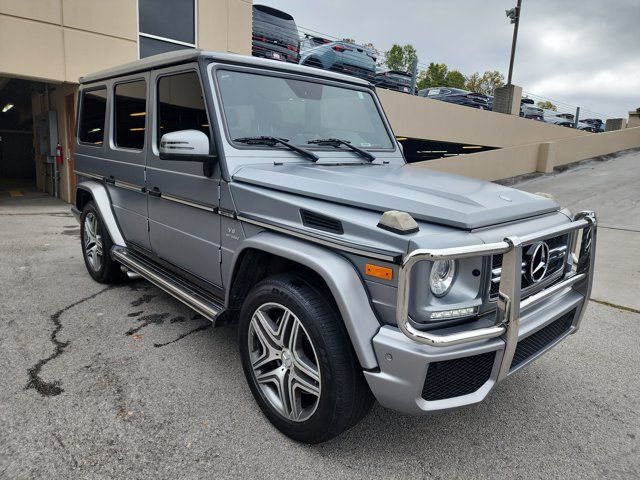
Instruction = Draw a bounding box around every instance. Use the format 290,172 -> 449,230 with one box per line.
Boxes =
378,89 -> 590,147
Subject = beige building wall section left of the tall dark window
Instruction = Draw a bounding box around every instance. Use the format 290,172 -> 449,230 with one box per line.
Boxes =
0,0 -> 138,82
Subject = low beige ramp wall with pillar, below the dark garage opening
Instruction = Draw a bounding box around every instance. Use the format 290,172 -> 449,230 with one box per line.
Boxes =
411,127 -> 640,180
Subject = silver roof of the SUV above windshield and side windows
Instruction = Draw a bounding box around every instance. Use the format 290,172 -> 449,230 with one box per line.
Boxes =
80,49 -> 372,86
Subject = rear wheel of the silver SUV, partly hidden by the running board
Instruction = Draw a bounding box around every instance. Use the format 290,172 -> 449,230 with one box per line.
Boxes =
80,202 -> 124,283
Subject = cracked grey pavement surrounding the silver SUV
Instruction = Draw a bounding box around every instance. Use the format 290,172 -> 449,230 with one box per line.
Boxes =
0,152 -> 640,479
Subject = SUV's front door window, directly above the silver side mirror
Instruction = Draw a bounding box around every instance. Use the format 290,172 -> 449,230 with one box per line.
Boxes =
157,72 -> 211,146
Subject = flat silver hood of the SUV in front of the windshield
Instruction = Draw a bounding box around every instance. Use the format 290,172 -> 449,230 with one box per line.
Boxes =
233,163 -> 560,230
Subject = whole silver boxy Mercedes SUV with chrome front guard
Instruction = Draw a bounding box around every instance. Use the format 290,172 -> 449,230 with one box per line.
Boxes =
73,50 -> 596,443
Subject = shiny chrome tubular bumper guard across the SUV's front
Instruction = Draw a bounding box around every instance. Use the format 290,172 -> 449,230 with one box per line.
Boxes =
396,211 -> 597,381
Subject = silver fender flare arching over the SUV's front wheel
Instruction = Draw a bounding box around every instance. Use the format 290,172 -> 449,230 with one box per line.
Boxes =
226,232 -> 380,369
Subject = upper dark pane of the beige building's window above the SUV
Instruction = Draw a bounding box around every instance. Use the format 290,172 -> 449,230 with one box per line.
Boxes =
138,0 -> 195,43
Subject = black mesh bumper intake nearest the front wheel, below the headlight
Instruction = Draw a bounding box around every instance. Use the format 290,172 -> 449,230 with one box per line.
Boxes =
422,352 -> 496,401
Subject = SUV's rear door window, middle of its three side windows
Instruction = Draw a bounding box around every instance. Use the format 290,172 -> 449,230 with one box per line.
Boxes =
113,80 -> 147,150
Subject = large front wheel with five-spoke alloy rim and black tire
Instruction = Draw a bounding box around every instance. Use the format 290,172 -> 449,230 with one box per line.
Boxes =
238,274 -> 373,443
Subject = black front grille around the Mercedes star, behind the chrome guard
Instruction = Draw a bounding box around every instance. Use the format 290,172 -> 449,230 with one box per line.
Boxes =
489,234 -> 569,300
